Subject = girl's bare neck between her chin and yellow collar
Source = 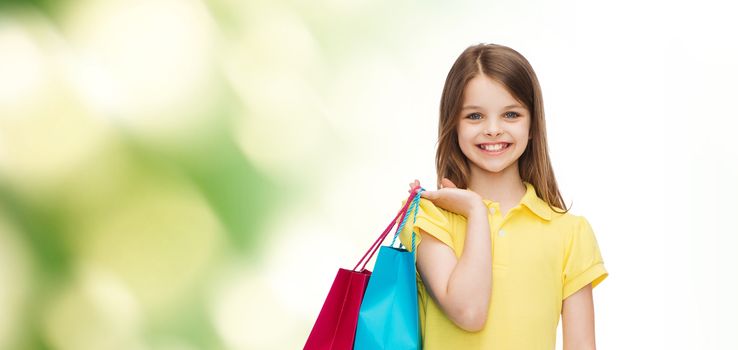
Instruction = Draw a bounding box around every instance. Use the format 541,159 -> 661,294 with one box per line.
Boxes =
468,163 -> 526,203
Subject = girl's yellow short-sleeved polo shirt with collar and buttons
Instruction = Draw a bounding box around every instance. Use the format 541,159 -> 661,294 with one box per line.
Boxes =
398,182 -> 608,350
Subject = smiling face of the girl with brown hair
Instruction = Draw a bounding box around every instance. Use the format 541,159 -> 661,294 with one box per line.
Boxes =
457,74 -> 531,175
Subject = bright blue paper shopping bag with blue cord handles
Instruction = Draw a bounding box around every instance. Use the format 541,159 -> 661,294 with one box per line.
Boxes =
354,188 -> 423,350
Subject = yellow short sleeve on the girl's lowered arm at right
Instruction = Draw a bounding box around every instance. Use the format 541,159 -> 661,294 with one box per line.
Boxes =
562,216 -> 608,300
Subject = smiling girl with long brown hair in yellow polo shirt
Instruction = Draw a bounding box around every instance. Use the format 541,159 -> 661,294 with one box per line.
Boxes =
400,44 -> 608,350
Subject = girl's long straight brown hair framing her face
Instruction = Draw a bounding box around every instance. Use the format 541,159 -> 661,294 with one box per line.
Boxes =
436,44 -> 570,213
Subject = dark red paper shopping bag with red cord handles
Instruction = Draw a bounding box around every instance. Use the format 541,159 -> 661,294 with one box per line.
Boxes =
304,187 -> 420,350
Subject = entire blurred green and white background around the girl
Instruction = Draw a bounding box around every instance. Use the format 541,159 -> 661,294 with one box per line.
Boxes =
0,0 -> 738,350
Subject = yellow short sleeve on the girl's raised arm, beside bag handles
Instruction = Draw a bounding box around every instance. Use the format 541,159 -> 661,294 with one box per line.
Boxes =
397,198 -> 454,251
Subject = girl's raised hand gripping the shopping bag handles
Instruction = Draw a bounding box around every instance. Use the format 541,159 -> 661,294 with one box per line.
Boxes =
408,178 -> 486,218
